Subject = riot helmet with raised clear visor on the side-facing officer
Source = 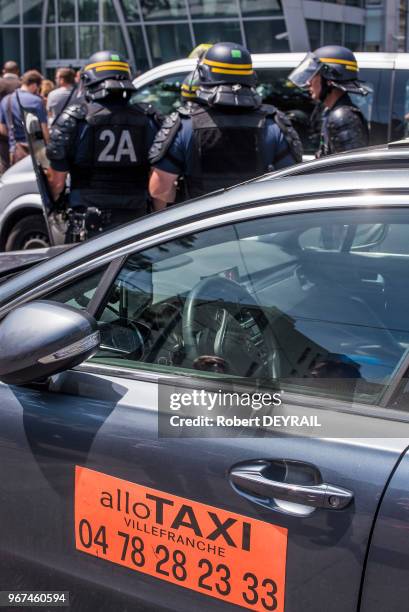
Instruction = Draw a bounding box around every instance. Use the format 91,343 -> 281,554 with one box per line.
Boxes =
288,45 -> 369,99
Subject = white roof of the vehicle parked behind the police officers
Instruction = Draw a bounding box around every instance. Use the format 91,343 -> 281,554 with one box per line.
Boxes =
133,52 -> 409,89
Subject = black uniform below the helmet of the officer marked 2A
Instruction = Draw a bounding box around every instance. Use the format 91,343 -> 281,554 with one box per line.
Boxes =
47,98 -> 158,237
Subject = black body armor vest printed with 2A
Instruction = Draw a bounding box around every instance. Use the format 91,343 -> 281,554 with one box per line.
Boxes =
70,104 -> 149,207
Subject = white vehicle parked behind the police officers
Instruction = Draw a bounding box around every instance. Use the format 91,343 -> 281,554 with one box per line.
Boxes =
0,53 -> 409,250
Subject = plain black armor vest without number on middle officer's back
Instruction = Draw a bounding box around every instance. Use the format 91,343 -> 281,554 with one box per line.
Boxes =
185,107 -> 268,198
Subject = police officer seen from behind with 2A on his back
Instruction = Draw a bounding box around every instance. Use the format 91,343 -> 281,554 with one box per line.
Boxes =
47,51 -> 159,235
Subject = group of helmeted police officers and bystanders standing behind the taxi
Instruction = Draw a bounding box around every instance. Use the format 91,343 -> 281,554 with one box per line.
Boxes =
0,43 -> 368,244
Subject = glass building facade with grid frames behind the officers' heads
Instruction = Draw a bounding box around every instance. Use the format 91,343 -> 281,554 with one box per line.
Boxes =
0,0 -> 289,74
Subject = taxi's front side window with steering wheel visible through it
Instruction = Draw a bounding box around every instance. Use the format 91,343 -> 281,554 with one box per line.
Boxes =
86,210 -> 409,402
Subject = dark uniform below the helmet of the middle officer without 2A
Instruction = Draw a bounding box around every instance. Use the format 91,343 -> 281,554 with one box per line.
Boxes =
150,98 -> 302,198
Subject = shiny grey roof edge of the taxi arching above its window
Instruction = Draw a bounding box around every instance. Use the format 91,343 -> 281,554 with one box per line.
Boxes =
0,169 -> 409,305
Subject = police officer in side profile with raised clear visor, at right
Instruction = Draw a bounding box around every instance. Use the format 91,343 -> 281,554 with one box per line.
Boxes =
289,45 -> 369,157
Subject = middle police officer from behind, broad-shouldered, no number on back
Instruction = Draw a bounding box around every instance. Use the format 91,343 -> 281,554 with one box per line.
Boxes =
149,43 -> 302,210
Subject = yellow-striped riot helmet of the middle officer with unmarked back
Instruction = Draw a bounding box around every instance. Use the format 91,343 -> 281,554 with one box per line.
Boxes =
196,42 -> 261,108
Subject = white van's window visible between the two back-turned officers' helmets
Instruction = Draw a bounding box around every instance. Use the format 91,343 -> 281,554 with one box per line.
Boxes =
131,72 -> 188,115
